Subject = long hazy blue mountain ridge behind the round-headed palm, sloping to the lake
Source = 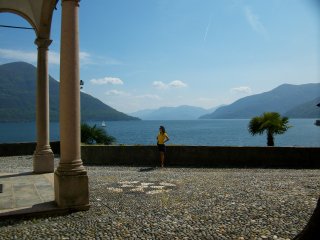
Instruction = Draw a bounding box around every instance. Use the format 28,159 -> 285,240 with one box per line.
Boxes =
200,83 -> 320,119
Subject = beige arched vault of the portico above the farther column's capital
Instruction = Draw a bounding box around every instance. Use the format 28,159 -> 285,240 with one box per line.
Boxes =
0,0 -> 58,38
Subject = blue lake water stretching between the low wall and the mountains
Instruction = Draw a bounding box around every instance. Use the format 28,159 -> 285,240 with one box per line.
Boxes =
0,119 -> 320,147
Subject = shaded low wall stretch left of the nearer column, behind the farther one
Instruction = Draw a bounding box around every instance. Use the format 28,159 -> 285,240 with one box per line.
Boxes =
0,142 -> 60,157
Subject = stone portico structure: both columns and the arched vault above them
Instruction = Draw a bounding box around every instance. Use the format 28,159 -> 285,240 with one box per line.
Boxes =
0,0 -> 89,214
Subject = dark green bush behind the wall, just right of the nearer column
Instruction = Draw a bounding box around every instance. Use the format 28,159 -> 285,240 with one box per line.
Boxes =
81,123 -> 116,145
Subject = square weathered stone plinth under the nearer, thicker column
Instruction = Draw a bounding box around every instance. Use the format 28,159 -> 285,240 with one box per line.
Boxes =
54,171 -> 90,210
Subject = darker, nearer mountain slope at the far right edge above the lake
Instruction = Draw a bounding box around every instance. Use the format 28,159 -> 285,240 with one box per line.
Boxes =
284,97 -> 320,118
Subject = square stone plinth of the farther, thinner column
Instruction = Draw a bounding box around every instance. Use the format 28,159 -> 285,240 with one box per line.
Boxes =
33,147 -> 54,173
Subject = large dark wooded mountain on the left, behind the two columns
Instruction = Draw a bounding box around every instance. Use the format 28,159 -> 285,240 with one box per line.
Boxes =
0,62 -> 138,122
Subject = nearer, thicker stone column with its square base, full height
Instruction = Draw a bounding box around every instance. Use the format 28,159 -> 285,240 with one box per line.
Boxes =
54,0 -> 89,210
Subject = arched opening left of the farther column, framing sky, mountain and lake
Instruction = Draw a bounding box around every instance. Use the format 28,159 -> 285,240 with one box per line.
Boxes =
0,12 -> 37,143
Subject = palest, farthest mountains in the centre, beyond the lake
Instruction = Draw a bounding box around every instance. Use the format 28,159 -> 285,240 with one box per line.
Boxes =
131,105 -> 220,120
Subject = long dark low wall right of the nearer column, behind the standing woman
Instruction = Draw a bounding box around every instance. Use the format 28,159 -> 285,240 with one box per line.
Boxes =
81,146 -> 320,168
